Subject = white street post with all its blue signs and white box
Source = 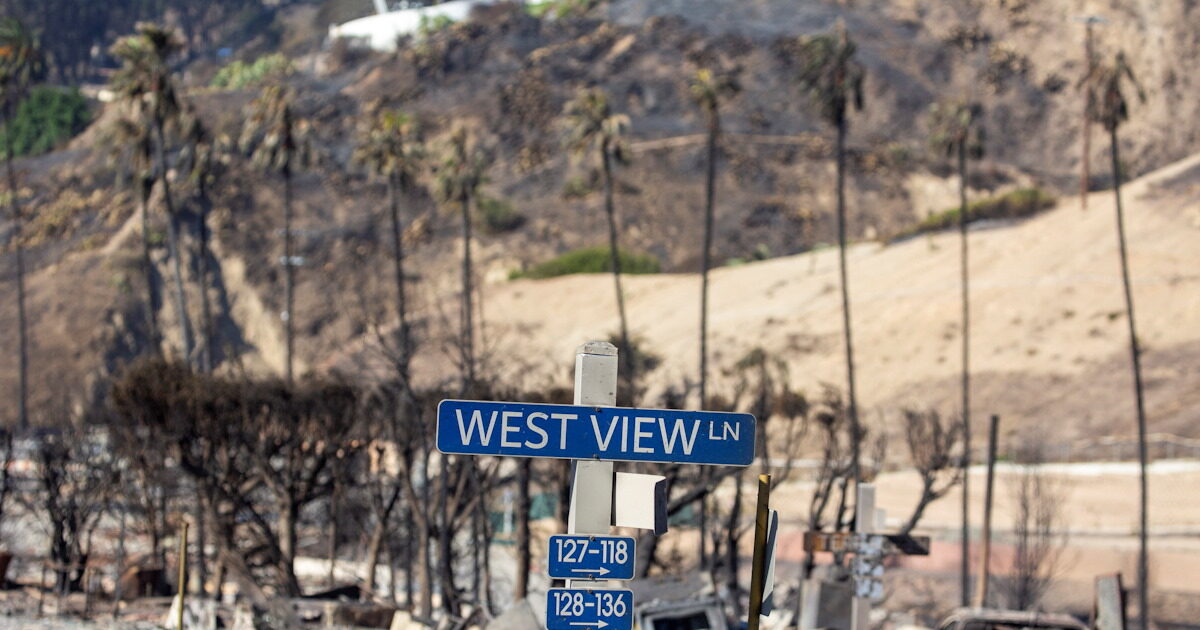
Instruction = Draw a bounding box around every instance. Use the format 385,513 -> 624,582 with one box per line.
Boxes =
437,341 -> 755,630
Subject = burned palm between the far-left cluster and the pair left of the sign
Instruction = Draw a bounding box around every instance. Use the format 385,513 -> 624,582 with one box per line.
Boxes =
239,84 -> 313,383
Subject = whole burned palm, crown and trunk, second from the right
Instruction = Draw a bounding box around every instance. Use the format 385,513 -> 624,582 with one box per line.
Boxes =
913,102 -> 983,606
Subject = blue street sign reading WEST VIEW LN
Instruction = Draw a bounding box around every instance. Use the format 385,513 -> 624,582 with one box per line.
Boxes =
438,401 -> 755,466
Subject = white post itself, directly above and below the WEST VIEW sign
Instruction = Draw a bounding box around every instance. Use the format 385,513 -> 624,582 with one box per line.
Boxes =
566,341 -> 617,534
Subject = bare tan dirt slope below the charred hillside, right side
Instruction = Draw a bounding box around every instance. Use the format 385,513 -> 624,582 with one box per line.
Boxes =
400,155 -> 1200,440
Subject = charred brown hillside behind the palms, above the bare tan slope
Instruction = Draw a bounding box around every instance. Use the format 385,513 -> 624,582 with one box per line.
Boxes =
0,0 -> 1200,422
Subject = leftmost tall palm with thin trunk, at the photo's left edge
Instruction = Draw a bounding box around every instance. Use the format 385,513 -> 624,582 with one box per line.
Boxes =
0,18 -> 46,428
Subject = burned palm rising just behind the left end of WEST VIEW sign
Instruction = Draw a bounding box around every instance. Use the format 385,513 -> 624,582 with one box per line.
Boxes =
434,126 -> 486,391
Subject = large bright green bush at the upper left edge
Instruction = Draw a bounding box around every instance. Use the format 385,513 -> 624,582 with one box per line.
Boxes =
0,85 -> 91,156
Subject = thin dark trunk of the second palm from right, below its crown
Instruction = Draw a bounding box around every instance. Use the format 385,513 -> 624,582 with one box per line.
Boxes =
955,139 -> 971,606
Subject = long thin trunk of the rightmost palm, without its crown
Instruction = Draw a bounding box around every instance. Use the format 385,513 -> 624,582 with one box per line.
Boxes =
1109,126 -> 1150,628
